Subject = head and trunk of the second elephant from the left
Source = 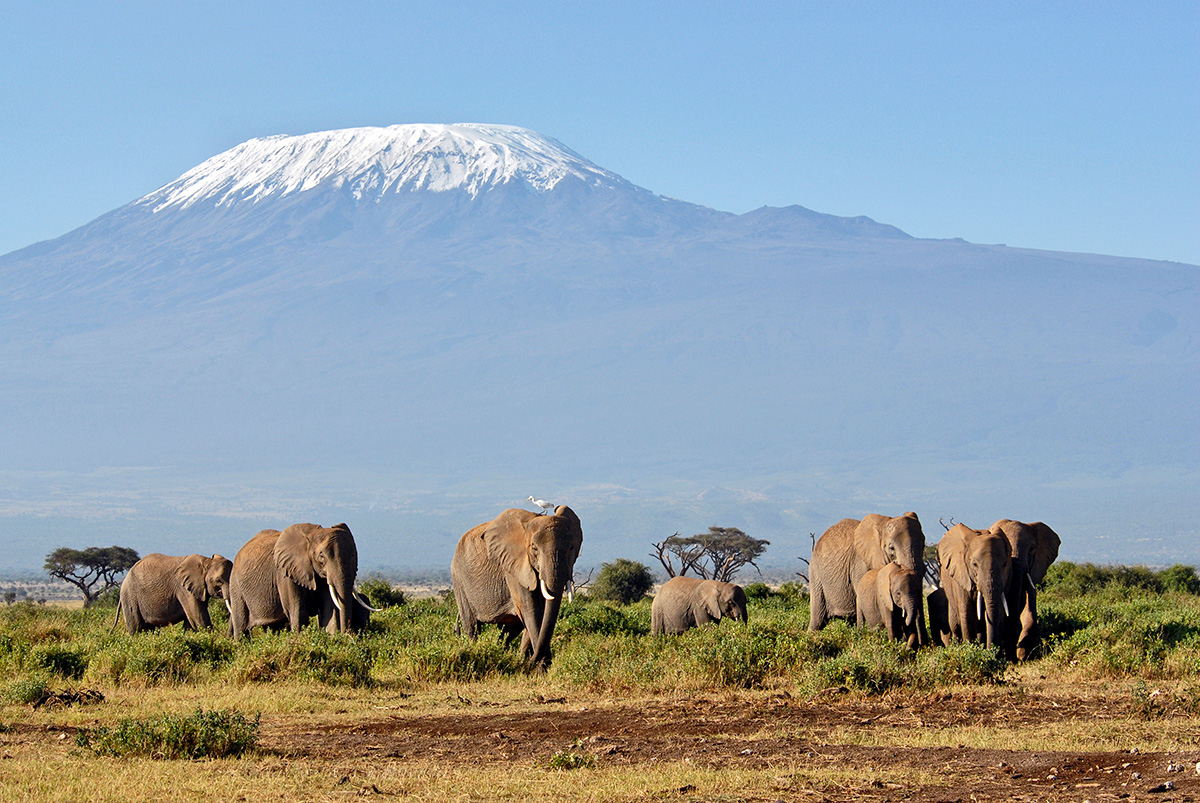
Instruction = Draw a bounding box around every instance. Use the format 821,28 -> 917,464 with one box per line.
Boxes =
275,525 -> 359,633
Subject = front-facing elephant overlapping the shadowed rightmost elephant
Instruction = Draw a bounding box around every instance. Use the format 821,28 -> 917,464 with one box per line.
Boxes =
937,525 -> 1013,647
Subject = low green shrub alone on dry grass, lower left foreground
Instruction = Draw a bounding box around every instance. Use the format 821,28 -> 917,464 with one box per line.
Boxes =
76,709 -> 259,759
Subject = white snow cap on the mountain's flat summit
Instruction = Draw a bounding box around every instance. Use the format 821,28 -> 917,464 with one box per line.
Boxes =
138,124 -> 629,212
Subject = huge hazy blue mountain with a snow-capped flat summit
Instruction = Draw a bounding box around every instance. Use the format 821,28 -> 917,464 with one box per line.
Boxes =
0,125 -> 1200,568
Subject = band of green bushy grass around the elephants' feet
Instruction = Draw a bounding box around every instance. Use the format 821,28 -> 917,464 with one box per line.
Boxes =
0,583 -> 1200,707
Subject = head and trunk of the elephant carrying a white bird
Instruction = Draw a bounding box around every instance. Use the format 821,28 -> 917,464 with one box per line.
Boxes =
484,504 -> 583,665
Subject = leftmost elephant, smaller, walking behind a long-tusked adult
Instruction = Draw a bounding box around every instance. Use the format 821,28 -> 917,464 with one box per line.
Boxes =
113,552 -> 233,635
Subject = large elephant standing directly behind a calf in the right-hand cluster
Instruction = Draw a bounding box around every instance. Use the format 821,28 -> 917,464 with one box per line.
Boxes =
809,511 -> 925,630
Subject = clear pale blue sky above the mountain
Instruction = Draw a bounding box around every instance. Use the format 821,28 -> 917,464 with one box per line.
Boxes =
0,0 -> 1200,264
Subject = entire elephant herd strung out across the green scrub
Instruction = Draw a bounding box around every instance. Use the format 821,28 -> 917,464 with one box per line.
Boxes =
118,505 -> 1060,667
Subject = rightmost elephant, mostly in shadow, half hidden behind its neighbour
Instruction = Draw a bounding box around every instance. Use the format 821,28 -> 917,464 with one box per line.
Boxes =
991,519 -> 1062,661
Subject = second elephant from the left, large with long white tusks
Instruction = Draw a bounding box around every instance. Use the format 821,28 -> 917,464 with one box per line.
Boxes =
229,523 -> 374,637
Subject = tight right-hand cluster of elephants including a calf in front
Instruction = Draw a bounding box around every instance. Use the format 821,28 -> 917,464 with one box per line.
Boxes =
809,513 -> 1060,660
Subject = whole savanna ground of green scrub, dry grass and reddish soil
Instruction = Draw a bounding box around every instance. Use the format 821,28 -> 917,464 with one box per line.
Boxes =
0,563 -> 1200,803
